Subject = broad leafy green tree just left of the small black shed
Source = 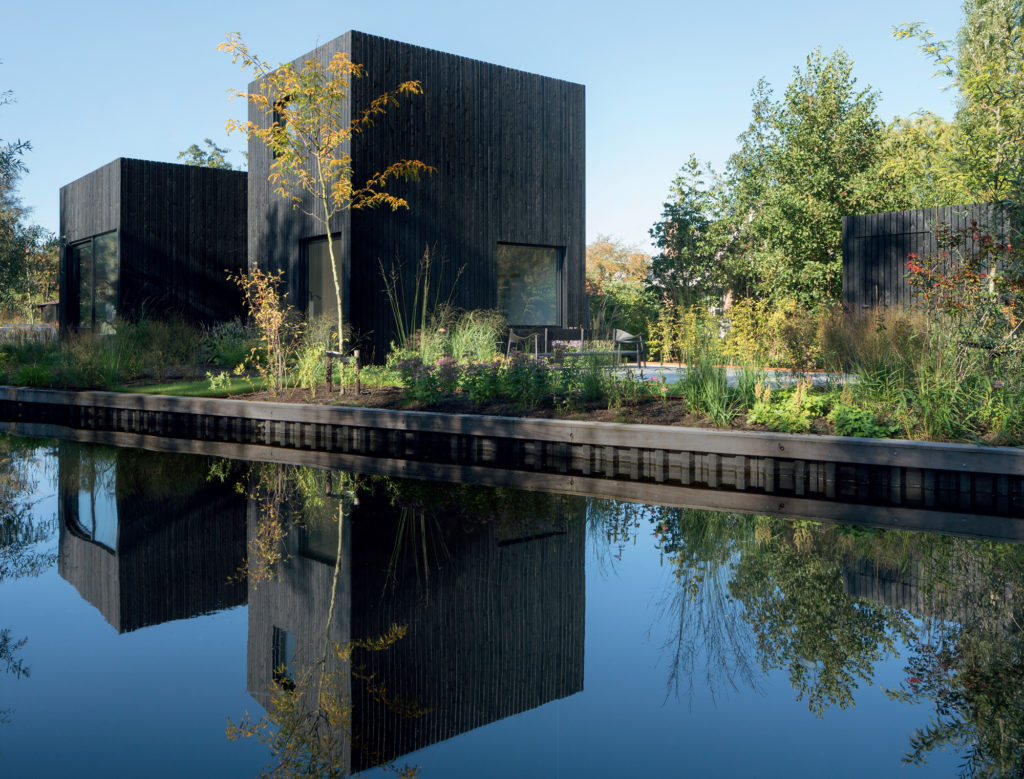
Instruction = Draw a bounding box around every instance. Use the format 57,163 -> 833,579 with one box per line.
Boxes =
727,49 -> 884,307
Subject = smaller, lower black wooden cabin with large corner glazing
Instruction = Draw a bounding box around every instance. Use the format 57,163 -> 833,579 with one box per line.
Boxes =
58,158 -> 247,333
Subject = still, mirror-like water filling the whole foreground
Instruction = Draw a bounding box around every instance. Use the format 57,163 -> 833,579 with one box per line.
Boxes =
0,438 -> 1024,777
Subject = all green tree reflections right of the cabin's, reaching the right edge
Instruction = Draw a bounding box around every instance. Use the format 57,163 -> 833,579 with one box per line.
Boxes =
638,507 -> 1024,776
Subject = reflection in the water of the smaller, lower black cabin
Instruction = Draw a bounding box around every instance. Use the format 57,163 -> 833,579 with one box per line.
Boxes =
57,443 -> 247,633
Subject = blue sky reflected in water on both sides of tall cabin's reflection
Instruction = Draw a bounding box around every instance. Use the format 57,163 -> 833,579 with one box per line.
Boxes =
0,438 -> 958,779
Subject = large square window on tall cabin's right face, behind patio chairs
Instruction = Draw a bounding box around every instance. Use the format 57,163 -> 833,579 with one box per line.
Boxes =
498,244 -> 562,326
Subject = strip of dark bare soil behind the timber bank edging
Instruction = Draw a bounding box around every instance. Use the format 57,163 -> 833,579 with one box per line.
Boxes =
231,384 -> 833,435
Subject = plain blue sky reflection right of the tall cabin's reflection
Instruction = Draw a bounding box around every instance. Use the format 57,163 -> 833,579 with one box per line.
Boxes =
389,522 -> 959,779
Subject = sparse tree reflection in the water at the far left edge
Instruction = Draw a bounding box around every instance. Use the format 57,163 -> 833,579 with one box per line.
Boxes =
0,437 -> 56,724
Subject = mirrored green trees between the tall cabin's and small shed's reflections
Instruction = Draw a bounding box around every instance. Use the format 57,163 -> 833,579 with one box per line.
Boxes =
618,508 -> 908,716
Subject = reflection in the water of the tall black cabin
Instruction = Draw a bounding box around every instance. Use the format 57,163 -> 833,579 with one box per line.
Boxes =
248,487 -> 585,772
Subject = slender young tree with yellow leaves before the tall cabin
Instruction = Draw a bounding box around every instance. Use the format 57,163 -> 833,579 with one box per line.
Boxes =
217,33 -> 434,351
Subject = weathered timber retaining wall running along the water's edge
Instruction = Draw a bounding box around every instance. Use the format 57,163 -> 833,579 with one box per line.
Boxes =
0,387 -> 1024,520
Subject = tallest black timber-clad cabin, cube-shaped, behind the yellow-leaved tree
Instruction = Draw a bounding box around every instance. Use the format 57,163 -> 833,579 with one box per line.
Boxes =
249,32 -> 587,361
